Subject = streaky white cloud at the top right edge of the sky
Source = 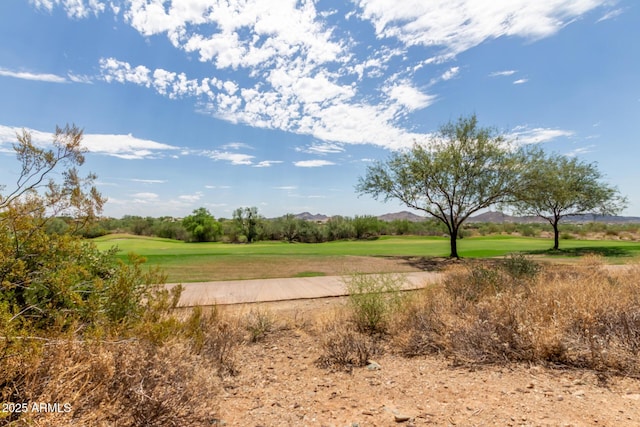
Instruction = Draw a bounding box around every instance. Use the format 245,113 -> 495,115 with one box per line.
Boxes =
358,0 -> 608,55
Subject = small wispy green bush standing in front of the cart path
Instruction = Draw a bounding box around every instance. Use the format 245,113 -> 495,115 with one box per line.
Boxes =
345,273 -> 404,334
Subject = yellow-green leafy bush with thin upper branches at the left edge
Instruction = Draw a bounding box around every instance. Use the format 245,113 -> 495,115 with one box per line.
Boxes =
0,126 -> 180,330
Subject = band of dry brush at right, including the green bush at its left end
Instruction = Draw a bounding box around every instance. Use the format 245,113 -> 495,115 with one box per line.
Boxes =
319,256 -> 640,376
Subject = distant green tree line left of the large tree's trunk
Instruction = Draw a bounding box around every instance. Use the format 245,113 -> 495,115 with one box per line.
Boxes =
53,207 -> 446,243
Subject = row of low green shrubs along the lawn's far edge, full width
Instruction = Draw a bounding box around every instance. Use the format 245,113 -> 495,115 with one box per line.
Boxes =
48,214 -> 640,243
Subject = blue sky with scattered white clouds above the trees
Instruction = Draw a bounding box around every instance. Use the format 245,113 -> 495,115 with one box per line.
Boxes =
0,0 -> 640,217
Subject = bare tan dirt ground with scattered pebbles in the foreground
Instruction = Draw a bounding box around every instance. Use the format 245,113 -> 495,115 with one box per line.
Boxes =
216,298 -> 640,427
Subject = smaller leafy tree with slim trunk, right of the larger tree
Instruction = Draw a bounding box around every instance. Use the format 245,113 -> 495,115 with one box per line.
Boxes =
513,148 -> 627,250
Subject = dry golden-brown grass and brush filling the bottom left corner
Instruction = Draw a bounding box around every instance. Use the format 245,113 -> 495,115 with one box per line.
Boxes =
0,309 -> 246,427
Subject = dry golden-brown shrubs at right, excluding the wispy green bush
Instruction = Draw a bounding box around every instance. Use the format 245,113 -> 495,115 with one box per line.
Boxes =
394,256 -> 640,376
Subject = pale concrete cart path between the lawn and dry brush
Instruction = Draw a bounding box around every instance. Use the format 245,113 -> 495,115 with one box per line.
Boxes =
167,272 -> 442,307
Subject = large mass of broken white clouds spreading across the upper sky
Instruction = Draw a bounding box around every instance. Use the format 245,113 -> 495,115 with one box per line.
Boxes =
86,0 -> 609,152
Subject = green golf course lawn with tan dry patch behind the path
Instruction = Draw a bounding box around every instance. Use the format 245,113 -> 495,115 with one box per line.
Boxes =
94,235 -> 640,282
